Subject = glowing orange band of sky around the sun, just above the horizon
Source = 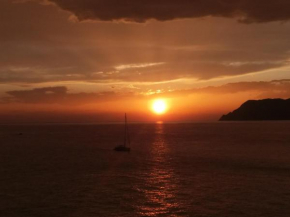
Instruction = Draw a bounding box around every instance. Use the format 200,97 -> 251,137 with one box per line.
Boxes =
0,88 -> 259,123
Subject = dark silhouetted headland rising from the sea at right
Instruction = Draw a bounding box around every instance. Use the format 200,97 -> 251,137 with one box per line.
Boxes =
220,99 -> 290,121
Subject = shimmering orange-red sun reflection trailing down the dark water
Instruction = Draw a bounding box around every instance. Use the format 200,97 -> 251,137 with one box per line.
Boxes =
139,124 -> 179,216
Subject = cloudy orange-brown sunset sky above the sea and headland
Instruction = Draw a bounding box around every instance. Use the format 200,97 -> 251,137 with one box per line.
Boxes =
0,0 -> 290,123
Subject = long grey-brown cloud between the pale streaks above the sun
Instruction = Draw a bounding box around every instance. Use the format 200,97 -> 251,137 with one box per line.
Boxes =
108,59 -> 288,82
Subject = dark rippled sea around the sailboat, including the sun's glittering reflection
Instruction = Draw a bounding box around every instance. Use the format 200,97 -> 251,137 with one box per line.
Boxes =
0,122 -> 290,217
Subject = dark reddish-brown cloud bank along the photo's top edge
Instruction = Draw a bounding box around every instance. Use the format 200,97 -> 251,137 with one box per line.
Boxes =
50,0 -> 290,23
